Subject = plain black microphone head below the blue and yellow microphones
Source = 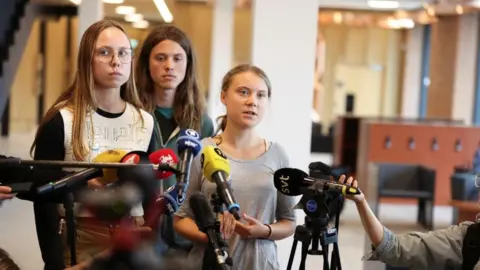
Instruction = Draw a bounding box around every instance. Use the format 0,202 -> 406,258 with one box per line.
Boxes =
189,192 -> 215,233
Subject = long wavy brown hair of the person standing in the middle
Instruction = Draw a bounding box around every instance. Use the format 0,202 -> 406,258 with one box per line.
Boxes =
136,24 -> 205,131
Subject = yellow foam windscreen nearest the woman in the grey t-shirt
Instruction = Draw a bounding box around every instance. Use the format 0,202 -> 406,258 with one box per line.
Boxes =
201,145 -> 230,182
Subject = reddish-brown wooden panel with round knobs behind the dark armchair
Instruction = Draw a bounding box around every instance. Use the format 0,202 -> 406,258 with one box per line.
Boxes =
357,123 -> 480,205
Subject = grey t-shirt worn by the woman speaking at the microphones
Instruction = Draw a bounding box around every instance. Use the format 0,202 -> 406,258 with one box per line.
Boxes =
176,138 -> 296,270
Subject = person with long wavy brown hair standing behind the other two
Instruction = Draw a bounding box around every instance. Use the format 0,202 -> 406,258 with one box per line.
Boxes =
136,24 -> 213,254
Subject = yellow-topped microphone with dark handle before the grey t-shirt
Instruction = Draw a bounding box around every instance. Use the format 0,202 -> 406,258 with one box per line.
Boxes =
201,145 -> 240,220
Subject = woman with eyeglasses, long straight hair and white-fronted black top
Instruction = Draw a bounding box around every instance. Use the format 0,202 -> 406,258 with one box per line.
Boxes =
31,20 -> 153,270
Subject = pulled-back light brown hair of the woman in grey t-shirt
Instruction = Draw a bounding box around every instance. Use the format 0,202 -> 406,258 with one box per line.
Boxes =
215,64 -> 272,134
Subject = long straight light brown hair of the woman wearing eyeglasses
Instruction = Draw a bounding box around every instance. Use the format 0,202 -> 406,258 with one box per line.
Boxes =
30,20 -> 143,160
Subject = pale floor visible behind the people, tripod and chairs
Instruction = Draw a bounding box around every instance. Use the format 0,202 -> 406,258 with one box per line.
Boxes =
0,134 -> 452,270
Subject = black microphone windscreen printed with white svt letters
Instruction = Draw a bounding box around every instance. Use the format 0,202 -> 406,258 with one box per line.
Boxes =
273,168 -> 308,196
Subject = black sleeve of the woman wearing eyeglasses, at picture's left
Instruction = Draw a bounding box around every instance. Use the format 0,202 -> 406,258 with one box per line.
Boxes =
29,113 -> 65,270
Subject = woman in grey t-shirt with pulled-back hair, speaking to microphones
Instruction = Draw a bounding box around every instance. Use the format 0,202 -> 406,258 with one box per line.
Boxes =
175,65 -> 296,270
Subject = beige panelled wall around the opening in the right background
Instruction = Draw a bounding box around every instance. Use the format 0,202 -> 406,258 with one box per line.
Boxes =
319,25 -> 403,128
